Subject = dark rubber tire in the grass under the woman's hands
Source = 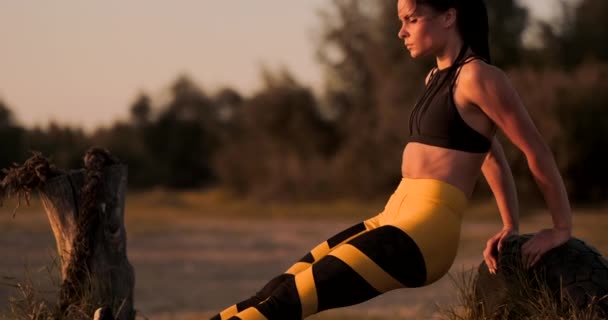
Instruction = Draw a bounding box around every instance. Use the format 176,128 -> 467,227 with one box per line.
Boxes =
475,234 -> 608,319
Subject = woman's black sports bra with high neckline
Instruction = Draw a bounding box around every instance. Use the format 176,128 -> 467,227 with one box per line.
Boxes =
409,46 -> 492,153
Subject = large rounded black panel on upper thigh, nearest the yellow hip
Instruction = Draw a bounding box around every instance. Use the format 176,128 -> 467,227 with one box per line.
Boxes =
349,225 -> 426,288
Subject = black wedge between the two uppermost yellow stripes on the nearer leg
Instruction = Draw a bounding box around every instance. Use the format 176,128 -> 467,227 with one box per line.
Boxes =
312,256 -> 380,311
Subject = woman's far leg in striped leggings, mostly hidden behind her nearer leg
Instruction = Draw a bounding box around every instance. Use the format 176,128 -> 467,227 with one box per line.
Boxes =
211,217 -> 377,320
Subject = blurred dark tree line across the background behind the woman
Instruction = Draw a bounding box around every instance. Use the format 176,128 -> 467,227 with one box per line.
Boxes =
0,0 -> 608,203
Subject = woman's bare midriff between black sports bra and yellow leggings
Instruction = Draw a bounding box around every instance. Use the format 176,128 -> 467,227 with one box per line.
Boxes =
401,142 -> 486,198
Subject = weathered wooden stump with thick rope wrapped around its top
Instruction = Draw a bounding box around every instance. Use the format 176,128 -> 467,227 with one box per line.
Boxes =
3,148 -> 135,320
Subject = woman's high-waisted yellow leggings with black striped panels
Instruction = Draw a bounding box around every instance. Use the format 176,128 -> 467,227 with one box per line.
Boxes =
211,178 -> 467,320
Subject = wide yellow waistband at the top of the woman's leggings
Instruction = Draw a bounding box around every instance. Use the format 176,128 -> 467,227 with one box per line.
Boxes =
396,178 -> 468,212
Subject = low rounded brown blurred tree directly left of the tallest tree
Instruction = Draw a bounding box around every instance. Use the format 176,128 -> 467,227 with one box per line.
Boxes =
214,70 -> 337,199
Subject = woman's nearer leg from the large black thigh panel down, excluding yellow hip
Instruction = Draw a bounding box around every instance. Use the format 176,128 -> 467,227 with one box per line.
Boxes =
229,225 -> 426,320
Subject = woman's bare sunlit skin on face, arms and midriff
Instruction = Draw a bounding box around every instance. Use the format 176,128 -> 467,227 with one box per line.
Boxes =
397,0 -> 572,273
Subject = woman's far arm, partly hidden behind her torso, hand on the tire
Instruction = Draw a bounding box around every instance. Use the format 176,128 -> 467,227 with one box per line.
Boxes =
481,137 -> 519,273
